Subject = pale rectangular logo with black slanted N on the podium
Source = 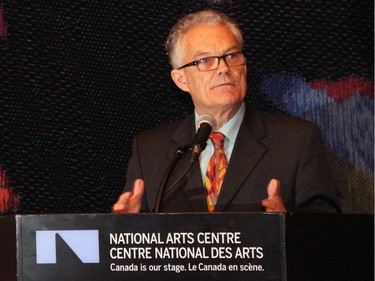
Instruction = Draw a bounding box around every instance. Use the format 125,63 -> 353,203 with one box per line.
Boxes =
36,230 -> 99,264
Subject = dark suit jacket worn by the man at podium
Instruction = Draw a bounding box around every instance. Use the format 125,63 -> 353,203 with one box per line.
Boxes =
125,107 -> 339,212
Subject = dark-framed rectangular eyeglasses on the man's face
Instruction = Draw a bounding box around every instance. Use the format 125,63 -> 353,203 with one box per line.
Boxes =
178,52 -> 246,71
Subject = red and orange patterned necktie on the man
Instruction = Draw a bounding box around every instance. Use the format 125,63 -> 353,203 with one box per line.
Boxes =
205,132 -> 228,212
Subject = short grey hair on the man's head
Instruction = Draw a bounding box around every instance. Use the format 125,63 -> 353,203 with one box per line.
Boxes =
165,10 -> 244,69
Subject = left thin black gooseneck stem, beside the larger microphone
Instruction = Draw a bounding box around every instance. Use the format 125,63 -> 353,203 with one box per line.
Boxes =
150,145 -> 189,214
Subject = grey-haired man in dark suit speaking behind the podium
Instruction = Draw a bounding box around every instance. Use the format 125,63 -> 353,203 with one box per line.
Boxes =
112,10 -> 339,213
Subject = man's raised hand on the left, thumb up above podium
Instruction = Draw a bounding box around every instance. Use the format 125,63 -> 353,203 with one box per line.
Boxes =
112,179 -> 145,214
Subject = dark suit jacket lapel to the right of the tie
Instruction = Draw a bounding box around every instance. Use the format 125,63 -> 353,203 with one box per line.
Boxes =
216,107 -> 267,212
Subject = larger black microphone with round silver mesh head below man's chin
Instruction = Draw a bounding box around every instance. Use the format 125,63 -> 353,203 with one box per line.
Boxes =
191,115 -> 217,162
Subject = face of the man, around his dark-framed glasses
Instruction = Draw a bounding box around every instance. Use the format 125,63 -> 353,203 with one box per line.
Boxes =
172,25 -> 247,115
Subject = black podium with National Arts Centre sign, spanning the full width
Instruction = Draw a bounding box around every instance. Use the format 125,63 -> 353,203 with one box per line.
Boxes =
0,213 -> 374,281
